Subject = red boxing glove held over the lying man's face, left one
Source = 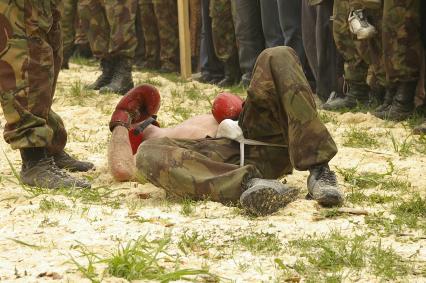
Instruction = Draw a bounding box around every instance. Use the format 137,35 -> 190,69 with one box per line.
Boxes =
109,84 -> 160,131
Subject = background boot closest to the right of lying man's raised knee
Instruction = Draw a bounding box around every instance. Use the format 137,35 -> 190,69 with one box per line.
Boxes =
322,84 -> 370,111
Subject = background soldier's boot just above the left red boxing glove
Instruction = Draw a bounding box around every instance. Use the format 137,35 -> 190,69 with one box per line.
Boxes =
100,57 -> 134,95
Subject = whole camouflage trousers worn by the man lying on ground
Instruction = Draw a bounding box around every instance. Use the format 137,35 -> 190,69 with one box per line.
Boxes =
136,46 -> 337,203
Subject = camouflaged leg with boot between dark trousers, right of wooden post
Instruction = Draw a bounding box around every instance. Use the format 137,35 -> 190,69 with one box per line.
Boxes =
210,0 -> 241,87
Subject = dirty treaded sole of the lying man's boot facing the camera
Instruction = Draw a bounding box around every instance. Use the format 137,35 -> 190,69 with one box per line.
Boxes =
240,186 -> 299,216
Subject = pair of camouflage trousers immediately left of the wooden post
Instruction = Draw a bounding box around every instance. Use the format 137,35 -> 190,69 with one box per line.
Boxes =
139,0 -> 179,69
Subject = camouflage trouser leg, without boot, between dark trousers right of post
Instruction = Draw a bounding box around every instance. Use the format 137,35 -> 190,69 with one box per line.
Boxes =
210,0 -> 238,62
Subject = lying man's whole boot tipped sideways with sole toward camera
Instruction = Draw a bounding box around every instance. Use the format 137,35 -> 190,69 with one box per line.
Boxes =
240,178 -> 299,216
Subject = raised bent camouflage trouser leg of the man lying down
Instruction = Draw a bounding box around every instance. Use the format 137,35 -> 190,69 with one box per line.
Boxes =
239,47 -> 337,170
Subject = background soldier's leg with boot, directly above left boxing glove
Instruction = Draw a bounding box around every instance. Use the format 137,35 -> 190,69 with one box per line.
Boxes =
100,0 -> 138,95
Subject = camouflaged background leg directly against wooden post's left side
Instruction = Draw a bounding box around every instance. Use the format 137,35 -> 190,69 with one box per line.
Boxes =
153,0 -> 179,72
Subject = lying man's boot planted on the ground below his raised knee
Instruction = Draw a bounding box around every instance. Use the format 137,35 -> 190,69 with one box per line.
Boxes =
306,164 -> 344,207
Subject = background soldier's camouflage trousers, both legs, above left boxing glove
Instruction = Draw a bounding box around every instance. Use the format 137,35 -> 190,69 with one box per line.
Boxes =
78,0 -> 137,59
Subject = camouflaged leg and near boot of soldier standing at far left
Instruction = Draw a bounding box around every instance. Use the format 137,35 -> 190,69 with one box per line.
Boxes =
0,1 -> 93,188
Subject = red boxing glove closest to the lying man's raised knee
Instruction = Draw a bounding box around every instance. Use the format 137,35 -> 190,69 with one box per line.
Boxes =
212,92 -> 244,124
